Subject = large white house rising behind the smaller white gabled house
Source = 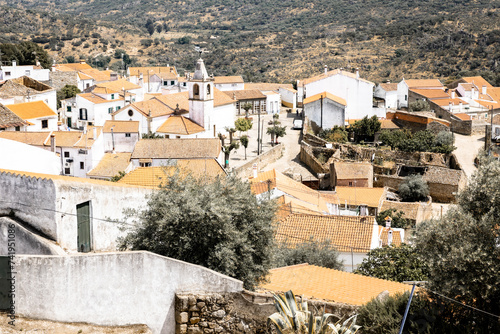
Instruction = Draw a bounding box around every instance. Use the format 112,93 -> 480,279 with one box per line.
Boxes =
299,67 -> 376,120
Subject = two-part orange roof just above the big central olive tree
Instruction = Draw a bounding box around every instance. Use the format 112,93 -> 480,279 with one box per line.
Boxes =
118,159 -> 226,187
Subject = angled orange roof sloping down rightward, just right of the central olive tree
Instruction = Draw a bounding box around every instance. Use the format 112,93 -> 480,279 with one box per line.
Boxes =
250,169 -> 328,213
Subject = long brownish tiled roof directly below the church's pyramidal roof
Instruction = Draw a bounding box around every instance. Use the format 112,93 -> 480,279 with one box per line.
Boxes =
132,138 -> 221,159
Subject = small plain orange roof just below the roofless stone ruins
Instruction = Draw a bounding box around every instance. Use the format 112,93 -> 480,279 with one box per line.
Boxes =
335,187 -> 387,208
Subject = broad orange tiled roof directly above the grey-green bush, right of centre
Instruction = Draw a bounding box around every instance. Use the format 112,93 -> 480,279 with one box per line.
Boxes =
275,213 -> 376,253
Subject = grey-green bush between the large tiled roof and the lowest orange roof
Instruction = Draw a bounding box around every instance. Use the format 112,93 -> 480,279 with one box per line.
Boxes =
273,238 -> 344,270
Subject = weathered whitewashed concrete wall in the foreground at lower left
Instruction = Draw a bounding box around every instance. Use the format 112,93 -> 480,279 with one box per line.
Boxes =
15,252 -> 243,334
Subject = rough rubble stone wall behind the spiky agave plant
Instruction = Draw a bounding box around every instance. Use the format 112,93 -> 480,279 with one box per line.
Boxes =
175,291 -> 358,334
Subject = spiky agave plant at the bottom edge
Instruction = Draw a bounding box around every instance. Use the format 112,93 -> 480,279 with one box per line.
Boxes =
267,290 -> 361,334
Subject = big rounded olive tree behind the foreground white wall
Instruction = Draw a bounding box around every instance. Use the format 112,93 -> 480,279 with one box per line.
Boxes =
119,172 -> 276,289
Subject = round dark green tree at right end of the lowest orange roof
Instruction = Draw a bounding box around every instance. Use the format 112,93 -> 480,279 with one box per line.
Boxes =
355,244 -> 429,282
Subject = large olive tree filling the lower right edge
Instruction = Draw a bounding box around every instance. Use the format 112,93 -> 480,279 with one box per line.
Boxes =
415,158 -> 500,333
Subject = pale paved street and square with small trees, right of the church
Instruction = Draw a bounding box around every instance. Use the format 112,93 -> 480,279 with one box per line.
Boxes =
229,108 -> 316,180
